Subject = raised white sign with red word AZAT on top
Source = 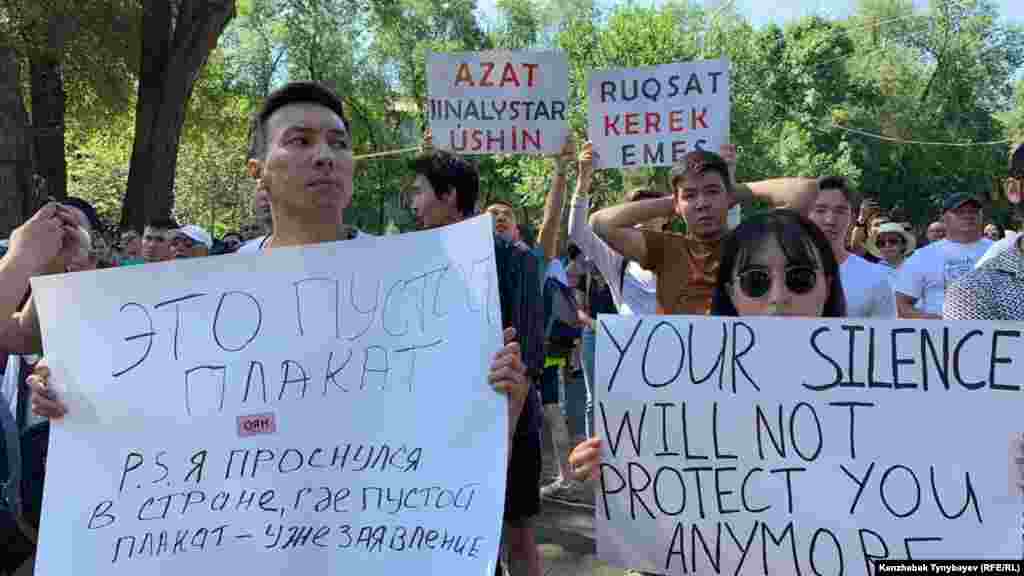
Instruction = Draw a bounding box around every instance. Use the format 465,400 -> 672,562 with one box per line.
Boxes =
427,51 -> 568,154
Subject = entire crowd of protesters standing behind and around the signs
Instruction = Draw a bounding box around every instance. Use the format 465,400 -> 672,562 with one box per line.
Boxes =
0,77 -> 1024,576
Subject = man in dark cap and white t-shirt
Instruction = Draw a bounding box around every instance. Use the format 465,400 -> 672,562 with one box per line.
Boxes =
896,193 -> 992,320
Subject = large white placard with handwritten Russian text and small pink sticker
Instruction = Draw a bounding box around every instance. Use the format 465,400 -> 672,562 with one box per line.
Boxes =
33,216 -> 508,576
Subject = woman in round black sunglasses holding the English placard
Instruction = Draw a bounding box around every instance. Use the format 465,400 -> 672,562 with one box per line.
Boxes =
569,210 -> 846,481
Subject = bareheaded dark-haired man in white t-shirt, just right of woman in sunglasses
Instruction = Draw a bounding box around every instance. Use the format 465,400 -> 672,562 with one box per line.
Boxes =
808,176 -> 896,318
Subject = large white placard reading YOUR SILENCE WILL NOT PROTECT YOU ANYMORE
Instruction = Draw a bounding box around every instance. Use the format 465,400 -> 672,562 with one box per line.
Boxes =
594,316 -> 1024,576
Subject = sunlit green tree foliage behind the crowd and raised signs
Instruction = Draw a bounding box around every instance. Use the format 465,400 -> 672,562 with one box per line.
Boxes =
54,0 -> 1024,234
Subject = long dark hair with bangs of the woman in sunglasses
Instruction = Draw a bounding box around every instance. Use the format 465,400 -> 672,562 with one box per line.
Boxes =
711,210 -> 846,318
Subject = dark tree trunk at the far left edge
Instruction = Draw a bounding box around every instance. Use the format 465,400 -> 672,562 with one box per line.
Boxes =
0,46 -> 32,233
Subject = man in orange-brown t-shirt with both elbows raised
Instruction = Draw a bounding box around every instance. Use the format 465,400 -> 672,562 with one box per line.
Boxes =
591,145 -> 817,315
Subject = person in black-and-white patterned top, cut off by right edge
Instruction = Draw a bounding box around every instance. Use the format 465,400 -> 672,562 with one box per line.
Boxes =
942,140 -> 1024,321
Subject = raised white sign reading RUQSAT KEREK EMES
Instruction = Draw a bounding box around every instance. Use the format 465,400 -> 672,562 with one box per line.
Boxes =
587,59 -> 730,168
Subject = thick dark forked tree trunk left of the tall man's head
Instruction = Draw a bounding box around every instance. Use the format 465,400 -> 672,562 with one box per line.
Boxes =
121,0 -> 234,230
